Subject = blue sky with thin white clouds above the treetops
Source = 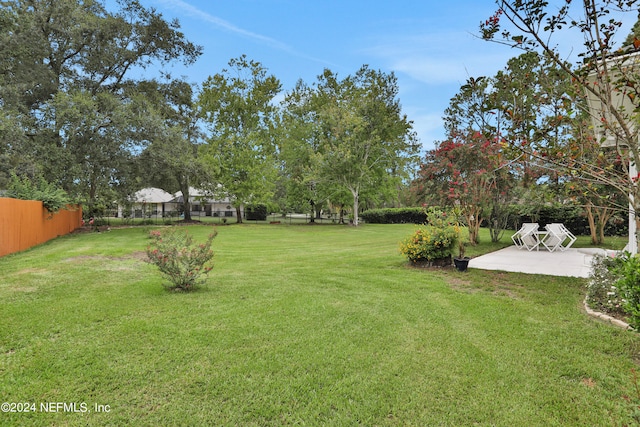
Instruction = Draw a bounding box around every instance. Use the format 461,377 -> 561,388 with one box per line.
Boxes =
126,0 -> 636,149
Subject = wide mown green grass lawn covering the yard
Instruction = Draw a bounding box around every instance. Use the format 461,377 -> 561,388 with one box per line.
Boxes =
0,225 -> 640,426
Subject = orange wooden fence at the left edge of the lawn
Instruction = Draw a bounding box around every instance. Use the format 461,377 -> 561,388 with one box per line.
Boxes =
0,197 -> 82,256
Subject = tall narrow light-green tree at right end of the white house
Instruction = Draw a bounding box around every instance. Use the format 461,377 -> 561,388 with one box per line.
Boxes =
199,55 -> 281,222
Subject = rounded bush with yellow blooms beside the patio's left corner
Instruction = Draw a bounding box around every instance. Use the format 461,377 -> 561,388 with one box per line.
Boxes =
400,209 -> 460,262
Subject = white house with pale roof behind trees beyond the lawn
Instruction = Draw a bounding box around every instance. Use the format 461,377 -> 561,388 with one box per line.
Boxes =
118,187 -> 241,218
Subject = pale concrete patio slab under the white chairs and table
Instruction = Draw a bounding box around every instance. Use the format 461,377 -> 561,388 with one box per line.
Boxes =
469,246 -> 611,277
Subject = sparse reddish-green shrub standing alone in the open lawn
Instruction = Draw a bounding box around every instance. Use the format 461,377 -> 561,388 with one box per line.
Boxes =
147,228 -> 217,291
